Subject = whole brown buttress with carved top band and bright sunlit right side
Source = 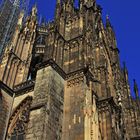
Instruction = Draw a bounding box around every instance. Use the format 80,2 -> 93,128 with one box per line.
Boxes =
62,74 -> 100,140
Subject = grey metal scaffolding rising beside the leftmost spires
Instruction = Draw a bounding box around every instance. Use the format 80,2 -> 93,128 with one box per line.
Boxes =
0,0 -> 29,60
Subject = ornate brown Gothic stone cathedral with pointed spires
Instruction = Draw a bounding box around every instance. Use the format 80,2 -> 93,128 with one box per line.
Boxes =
0,0 -> 140,140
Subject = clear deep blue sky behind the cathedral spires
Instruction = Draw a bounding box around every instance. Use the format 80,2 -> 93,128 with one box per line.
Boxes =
31,0 -> 140,96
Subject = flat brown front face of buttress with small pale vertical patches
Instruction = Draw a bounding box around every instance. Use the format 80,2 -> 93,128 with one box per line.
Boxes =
62,74 -> 86,140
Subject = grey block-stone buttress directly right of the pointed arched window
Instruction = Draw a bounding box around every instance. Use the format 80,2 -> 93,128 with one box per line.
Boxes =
25,66 -> 64,140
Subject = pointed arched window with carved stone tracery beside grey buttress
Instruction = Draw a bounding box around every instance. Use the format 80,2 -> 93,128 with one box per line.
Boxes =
8,96 -> 32,140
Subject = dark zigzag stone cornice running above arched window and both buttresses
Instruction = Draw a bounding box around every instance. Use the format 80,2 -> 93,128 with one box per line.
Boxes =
0,59 -> 100,96
